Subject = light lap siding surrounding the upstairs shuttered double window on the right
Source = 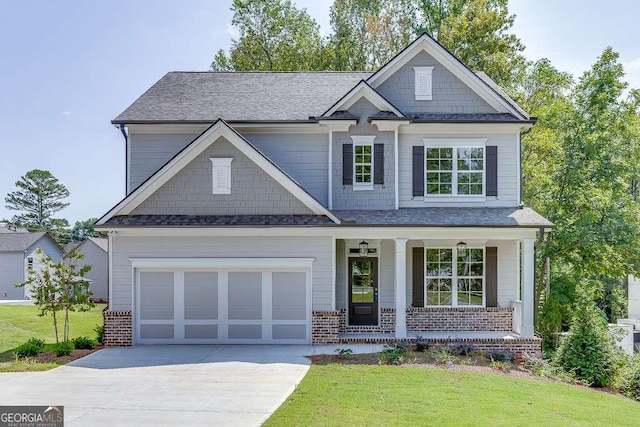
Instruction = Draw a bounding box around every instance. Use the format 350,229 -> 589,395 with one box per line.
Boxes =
398,133 -> 520,208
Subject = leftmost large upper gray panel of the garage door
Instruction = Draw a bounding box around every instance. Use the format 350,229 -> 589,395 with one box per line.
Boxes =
140,272 -> 175,320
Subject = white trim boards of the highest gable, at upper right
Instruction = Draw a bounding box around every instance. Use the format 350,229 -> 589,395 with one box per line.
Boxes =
367,33 -> 529,120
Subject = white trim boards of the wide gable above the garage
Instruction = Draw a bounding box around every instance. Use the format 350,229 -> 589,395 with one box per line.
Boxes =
96,120 -> 340,225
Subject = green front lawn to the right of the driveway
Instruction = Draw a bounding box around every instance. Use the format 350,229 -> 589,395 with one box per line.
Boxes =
264,364 -> 640,426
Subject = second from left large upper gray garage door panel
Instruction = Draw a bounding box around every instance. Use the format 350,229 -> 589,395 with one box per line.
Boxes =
184,272 -> 218,320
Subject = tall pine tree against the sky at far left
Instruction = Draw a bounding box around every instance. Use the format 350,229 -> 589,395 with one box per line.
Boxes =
4,169 -> 69,231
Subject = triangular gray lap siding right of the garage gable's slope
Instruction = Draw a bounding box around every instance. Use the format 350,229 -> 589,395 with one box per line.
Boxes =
242,133 -> 329,206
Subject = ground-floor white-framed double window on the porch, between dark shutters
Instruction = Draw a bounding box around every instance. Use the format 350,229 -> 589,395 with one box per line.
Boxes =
425,248 -> 484,306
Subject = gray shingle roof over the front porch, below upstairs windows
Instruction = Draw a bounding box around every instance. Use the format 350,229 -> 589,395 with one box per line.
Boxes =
333,207 -> 553,228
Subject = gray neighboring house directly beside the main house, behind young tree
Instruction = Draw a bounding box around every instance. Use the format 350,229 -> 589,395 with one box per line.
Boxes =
67,237 -> 109,302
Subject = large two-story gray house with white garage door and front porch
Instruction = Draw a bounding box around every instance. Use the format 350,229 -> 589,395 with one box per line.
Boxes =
97,35 -> 553,352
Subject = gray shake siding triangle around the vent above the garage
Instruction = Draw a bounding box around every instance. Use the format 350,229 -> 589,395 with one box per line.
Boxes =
132,138 -> 312,215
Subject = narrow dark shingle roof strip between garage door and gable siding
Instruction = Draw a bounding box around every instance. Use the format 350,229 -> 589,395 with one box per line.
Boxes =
105,215 -> 335,227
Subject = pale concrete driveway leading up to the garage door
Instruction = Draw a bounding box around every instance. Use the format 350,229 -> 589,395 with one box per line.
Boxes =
0,345 -> 315,426
